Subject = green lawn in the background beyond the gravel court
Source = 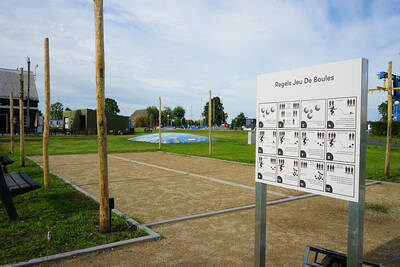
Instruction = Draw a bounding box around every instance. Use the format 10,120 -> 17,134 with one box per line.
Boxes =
0,129 -> 400,182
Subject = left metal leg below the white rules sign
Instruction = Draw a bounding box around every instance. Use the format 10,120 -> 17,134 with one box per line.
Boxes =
254,182 -> 267,267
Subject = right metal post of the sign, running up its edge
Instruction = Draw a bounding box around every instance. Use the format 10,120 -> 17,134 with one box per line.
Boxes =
347,59 -> 368,267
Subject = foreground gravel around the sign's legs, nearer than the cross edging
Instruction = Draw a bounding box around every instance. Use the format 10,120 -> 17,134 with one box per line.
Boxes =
52,184 -> 400,267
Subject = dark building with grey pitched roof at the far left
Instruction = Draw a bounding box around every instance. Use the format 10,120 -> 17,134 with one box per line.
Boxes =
0,68 -> 39,134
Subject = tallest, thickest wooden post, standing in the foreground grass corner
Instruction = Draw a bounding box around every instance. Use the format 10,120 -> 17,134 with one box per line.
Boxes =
93,0 -> 111,233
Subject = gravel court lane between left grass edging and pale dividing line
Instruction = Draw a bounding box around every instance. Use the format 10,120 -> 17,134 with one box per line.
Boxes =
31,153 -> 282,223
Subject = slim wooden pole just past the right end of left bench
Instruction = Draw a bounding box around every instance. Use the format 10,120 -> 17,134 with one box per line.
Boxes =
43,38 -> 50,186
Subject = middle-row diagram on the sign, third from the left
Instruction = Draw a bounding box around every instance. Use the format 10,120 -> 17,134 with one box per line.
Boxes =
300,131 -> 325,160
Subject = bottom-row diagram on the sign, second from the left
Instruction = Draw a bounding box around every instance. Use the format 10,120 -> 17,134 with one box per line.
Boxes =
276,158 -> 299,186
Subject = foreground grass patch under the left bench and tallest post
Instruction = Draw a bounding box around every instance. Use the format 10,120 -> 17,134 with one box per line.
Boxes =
0,153 -> 147,265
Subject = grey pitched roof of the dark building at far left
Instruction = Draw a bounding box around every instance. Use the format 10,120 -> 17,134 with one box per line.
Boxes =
0,68 -> 39,101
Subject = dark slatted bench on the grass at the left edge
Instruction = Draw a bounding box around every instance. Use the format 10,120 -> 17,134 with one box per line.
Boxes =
0,156 -> 42,221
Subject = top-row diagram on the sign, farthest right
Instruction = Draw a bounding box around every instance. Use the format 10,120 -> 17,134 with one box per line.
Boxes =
326,97 -> 357,129
